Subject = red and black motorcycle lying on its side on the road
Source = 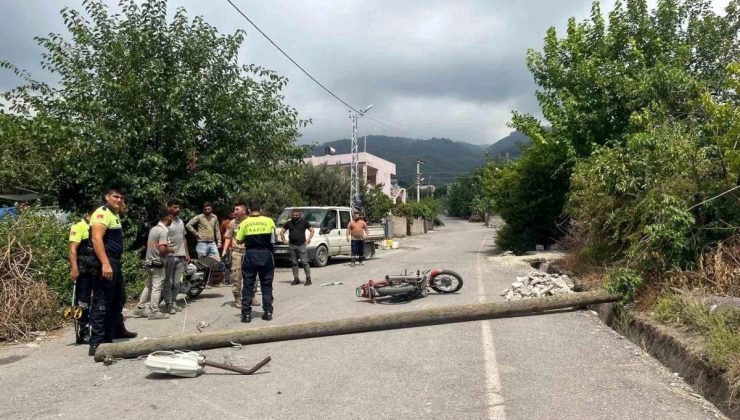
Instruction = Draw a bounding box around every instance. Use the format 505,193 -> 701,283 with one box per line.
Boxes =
355,269 -> 463,303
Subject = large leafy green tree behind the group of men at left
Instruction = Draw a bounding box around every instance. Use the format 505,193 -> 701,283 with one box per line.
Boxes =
2,0 -> 306,223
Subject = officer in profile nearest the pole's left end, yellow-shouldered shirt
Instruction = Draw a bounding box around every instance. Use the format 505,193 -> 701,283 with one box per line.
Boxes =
88,187 -> 136,356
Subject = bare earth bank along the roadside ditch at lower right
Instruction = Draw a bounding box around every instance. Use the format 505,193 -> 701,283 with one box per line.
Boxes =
588,303 -> 740,420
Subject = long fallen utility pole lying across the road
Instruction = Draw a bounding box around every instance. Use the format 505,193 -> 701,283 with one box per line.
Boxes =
95,291 -> 619,362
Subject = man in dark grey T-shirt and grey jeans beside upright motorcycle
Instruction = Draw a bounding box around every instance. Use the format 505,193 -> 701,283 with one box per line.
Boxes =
164,199 -> 190,315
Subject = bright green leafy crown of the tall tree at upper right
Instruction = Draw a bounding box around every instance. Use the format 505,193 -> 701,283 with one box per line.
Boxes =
514,0 -> 740,157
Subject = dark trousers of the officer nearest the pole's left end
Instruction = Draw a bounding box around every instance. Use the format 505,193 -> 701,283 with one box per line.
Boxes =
90,257 -> 126,345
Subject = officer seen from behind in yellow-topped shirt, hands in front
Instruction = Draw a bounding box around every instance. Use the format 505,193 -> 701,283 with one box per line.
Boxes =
236,201 -> 275,322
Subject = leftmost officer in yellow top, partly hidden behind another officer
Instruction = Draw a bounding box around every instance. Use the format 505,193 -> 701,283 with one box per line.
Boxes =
69,205 -> 97,344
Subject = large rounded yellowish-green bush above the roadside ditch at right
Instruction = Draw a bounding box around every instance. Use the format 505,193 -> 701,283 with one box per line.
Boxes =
567,125 -> 740,272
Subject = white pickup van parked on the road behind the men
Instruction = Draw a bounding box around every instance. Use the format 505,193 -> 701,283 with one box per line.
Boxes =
275,206 -> 385,267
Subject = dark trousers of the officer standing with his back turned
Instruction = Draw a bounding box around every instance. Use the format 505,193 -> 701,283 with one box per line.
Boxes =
242,249 -> 275,312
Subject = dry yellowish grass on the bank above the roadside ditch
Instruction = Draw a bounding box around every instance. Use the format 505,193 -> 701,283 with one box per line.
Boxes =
655,293 -> 740,404
